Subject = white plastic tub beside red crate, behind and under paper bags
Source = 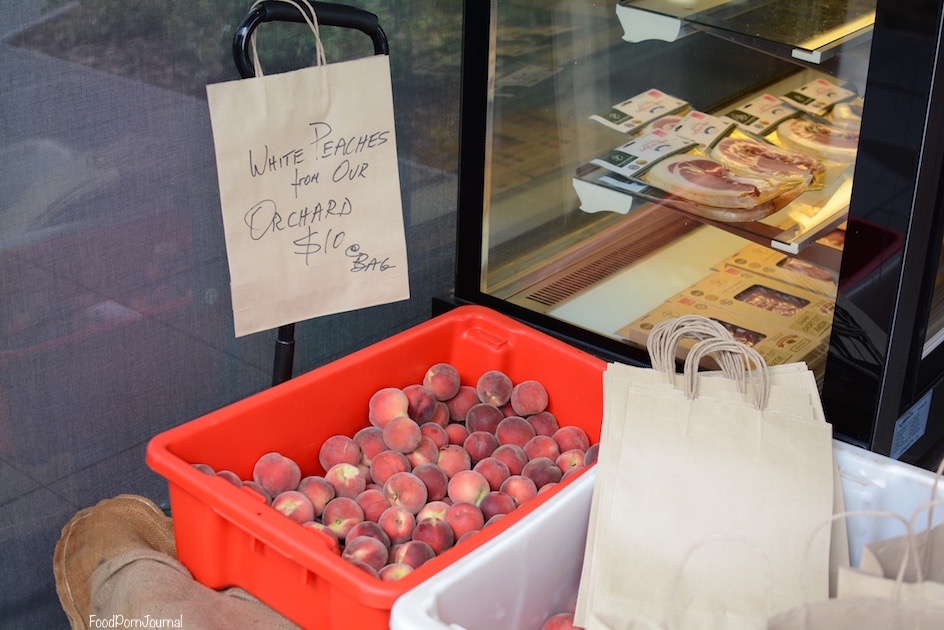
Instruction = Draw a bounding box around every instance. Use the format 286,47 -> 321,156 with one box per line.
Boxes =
390,441 -> 944,630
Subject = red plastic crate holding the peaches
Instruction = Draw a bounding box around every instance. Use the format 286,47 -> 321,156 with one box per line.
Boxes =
147,306 -> 606,630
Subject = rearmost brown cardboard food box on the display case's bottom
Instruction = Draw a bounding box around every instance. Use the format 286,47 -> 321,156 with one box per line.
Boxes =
714,243 -> 837,300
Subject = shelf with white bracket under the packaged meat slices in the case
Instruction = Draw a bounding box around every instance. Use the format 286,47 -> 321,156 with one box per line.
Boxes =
574,164 -> 853,269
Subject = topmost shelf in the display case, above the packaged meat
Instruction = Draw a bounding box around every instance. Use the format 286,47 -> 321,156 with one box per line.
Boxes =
616,0 -> 875,64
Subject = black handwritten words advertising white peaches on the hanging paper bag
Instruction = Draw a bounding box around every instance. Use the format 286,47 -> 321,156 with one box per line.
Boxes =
245,122 -> 396,272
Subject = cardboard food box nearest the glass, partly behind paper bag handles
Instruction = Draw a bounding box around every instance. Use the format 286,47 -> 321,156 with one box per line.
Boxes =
617,295 -> 825,371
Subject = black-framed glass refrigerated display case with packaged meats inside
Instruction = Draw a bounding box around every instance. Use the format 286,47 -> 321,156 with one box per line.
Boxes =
442,0 -> 944,466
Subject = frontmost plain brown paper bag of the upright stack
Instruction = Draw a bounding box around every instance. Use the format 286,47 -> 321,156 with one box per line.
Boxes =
578,340 -> 833,628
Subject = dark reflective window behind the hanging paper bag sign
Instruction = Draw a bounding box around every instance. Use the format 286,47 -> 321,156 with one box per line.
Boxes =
0,0 -> 461,628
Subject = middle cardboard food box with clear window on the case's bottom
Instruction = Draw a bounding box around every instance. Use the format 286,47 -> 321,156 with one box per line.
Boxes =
674,267 -> 836,340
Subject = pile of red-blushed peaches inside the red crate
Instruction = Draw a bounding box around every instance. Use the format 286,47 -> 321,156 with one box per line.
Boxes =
196,363 -> 599,580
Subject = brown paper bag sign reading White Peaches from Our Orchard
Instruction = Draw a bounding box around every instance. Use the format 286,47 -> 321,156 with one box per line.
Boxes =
207,55 -> 409,337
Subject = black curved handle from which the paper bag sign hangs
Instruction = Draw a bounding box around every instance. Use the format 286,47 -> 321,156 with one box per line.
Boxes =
233,0 -> 390,79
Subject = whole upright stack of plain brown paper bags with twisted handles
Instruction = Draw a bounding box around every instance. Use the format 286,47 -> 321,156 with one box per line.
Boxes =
575,317 -> 832,630
